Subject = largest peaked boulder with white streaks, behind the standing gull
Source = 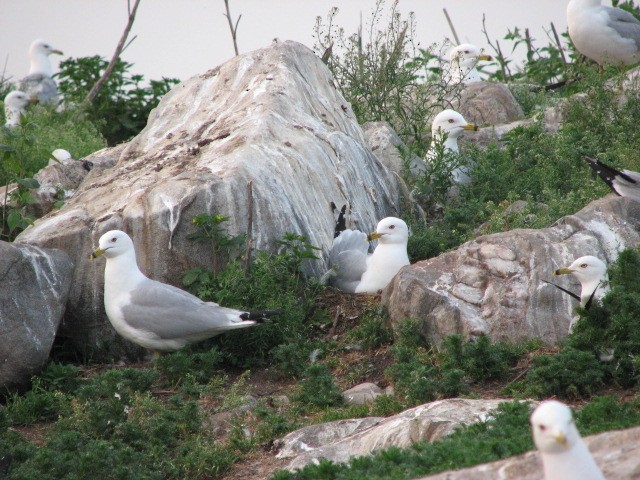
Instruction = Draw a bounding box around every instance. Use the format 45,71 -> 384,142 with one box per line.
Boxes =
18,42 -> 401,351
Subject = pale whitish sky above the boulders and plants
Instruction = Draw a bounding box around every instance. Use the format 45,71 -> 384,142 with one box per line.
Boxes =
0,0 -> 568,80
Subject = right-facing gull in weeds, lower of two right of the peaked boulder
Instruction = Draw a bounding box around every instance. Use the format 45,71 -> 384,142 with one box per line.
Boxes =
425,109 -> 478,184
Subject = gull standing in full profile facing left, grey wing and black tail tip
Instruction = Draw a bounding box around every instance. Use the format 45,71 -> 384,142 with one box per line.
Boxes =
91,230 -> 273,351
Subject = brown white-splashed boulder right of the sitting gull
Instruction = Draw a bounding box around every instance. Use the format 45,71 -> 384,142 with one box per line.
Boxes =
382,195 -> 640,344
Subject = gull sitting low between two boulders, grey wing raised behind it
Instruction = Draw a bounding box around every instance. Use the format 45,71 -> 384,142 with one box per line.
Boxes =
323,217 -> 409,293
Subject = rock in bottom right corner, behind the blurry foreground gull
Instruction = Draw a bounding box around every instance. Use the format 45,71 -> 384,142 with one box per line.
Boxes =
415,427 -> 640,480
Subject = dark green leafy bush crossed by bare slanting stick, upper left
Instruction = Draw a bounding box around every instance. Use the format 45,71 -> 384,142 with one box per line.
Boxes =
56,55 -> 178,145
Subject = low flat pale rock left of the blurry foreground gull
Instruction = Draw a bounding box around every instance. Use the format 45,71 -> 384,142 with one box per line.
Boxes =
277,398 -> 504,471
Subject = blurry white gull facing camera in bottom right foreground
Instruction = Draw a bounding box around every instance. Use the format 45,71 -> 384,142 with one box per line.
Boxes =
531,400 -> 604,480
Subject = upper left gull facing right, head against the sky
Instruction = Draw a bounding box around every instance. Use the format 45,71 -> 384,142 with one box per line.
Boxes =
20,39 -> 62,104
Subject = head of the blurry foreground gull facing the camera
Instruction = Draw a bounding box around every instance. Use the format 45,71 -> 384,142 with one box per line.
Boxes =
530,400 -> 580,454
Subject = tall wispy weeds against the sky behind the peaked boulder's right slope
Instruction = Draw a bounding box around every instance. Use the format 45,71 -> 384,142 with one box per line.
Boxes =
314,0 -> 453,149
